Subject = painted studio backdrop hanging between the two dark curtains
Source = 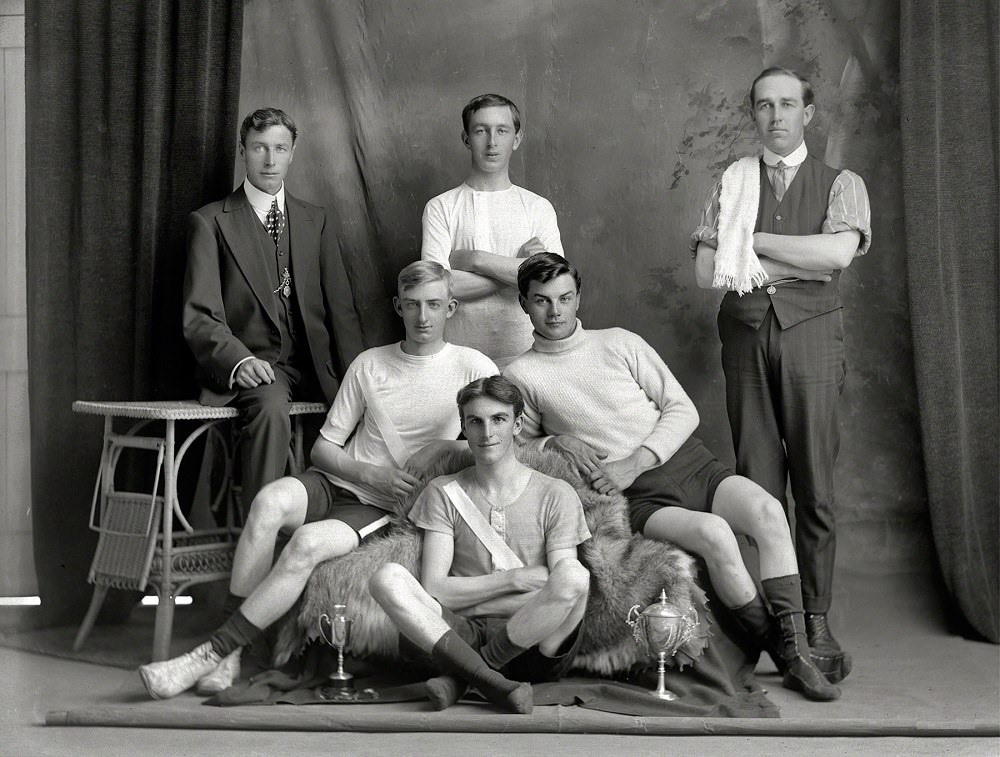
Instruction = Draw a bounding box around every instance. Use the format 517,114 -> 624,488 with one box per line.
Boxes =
240,0 -> 916,580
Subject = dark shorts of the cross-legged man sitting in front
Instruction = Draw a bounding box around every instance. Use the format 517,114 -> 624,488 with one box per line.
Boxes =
399,606 -> 583,683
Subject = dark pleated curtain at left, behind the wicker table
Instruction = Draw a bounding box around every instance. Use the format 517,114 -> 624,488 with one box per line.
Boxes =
26,0 -> 243,623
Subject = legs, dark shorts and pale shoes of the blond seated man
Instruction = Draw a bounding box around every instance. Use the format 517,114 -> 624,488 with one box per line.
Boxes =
139,471 -> 389,699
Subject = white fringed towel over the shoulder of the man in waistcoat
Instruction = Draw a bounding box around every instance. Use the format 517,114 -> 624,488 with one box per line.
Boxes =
712,157 -> 767,295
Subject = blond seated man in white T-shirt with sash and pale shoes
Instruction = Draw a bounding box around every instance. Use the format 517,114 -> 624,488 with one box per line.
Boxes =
139,261 -> 497,699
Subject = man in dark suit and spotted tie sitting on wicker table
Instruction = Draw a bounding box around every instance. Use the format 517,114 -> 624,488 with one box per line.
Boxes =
183,108 -> 364,512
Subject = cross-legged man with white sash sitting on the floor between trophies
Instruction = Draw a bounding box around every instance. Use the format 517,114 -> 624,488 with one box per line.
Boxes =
369,376 -> 590,713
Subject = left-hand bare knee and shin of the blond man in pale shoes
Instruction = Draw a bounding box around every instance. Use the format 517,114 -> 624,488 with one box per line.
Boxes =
229,477 -> 309,597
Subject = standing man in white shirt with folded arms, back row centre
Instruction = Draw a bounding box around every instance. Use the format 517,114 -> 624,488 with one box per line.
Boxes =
421,94 -> 563,368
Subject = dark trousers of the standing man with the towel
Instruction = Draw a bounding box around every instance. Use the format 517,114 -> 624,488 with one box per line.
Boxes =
718,310 -> 846,612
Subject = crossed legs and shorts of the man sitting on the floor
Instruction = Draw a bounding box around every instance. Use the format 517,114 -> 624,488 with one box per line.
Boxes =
369,559 -> 590,713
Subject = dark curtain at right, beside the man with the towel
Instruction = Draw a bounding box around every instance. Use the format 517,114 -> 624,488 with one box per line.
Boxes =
900,0 -> 1000,642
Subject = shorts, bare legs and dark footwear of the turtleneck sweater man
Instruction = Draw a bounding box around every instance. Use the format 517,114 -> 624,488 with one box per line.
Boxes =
625,448 -> 840,701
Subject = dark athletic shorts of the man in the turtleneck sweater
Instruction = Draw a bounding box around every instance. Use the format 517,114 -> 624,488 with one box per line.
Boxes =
625,436 -> 735,534
